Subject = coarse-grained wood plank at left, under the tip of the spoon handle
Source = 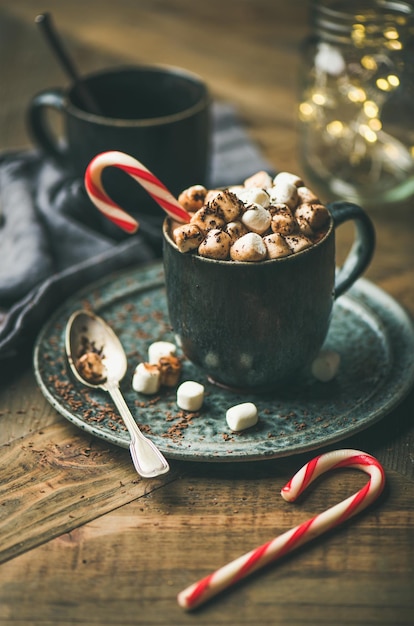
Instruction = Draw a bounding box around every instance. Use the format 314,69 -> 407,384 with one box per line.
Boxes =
0,418 -> 177,562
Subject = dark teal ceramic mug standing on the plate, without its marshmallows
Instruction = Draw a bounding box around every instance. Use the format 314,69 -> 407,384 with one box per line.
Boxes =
163,202 -> 375,391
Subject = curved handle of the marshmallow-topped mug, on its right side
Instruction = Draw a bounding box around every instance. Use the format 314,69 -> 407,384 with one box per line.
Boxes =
328,201 -> 375,299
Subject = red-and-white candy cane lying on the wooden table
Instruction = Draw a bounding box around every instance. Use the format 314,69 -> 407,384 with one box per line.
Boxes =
177,450 -> 385,609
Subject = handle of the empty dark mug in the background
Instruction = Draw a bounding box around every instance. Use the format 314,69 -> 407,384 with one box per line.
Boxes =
27,88 -> 66,160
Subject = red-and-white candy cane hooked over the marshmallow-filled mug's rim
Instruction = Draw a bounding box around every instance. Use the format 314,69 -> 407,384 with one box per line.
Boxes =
84,150 -> 190,233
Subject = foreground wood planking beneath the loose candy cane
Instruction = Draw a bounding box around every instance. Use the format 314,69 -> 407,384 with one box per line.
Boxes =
0,461 -> 414,626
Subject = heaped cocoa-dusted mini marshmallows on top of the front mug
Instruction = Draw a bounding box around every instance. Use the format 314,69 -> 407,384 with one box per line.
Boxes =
172,171 -> 329,262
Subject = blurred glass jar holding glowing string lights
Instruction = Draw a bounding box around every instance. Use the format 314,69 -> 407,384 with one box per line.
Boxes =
298,0 -> 414,206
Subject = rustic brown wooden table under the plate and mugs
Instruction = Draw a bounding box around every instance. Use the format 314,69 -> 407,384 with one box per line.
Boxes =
0,0 -> 414,626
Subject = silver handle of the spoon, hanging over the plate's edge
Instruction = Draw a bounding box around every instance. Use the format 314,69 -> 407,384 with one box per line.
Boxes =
106,384 -> 170,478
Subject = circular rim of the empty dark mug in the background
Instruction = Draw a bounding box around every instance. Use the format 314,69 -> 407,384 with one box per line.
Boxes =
65,63 -> 211,127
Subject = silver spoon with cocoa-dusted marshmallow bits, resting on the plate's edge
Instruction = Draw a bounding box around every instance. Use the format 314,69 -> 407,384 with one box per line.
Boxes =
65,310 -> 170,478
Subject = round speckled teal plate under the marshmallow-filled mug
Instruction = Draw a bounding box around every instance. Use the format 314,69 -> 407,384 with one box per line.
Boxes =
34,263 -> 414,461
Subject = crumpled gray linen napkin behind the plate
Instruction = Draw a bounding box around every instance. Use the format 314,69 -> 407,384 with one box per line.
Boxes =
0,103 -> 272,360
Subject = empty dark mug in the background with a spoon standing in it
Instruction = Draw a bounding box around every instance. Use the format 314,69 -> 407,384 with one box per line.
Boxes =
28,65 -> 210,232
